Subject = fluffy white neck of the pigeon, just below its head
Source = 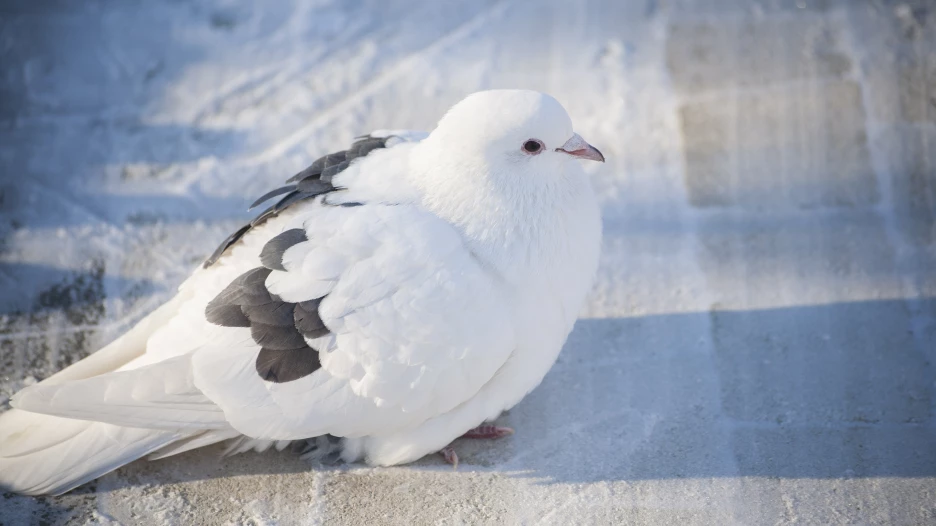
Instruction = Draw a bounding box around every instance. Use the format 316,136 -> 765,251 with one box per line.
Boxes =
412,148 -> 600,283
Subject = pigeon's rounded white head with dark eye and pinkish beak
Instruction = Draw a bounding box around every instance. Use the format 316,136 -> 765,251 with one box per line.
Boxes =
414,90 -> 604,208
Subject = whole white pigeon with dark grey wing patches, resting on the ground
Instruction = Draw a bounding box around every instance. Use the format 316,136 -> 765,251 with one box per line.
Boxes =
0,90 -> 604,495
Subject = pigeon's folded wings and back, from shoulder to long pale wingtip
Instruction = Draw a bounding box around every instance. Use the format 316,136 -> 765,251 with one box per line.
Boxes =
14,132 -> 514,440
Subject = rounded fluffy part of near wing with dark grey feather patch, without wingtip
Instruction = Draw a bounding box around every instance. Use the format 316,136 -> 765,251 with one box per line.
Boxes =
192,203 -> 514,439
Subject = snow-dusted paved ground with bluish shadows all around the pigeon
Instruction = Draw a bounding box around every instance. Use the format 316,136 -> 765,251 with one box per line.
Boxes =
0,0 -> 936,525
